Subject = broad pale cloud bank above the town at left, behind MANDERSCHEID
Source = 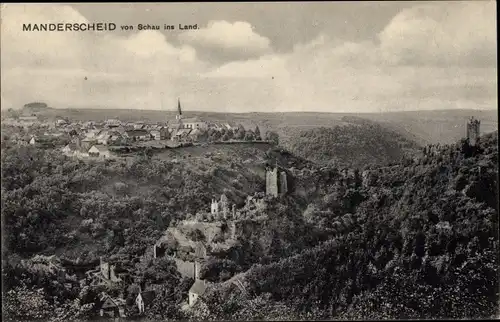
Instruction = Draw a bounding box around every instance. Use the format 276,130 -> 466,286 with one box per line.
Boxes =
1,4 -> 205,109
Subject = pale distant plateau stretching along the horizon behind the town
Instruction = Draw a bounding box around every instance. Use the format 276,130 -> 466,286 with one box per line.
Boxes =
11,108 -> 498,145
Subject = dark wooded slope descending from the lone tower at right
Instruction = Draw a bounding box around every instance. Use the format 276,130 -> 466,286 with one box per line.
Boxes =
198,133 -> 499,319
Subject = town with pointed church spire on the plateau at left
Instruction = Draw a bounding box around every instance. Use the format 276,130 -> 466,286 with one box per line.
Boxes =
2,99 -> 276,160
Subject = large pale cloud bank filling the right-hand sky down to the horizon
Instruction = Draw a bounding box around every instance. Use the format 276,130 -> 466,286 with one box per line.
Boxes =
203,2 -> 497,112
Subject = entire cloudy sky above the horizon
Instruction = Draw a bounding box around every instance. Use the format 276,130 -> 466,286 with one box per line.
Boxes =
0,0 -> 497,113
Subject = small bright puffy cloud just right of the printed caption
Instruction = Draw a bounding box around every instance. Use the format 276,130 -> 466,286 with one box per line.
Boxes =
179,21 -> 271,61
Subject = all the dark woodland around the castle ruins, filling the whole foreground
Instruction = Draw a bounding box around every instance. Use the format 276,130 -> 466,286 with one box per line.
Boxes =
1,121 -> 499,321
